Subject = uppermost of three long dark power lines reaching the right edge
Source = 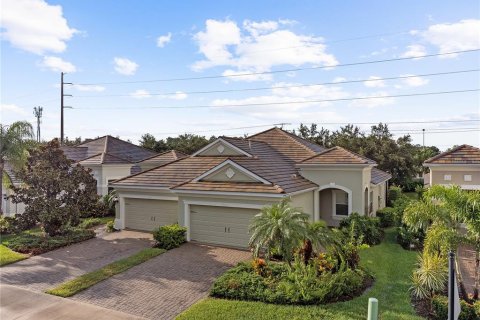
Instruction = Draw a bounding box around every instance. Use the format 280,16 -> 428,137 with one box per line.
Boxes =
75,49 -> 480,86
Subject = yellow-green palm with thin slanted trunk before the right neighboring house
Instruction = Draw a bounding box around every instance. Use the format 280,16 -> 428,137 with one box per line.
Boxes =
403,185 -> 467,298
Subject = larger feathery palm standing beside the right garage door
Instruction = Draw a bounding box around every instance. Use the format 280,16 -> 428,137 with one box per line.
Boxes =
249,198 -> 309,264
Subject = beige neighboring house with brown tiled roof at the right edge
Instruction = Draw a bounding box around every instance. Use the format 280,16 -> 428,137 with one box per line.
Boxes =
423,144 -> 480,190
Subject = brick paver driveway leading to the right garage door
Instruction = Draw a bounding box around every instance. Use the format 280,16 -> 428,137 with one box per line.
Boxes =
72,243 -> 251,319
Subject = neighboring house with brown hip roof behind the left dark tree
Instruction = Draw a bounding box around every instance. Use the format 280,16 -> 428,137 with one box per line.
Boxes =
62,135 -> 158,195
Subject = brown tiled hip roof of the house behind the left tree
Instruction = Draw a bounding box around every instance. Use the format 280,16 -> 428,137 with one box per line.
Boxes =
62,135 -> 157,165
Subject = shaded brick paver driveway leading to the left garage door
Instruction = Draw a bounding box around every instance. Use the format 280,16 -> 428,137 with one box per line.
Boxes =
0,231 -> 153,292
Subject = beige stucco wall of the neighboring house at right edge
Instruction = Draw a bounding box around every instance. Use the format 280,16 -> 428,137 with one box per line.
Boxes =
430,166 -> 480,186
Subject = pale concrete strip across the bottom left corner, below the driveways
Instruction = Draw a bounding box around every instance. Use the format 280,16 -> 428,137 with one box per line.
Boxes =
0,284 -> 142,320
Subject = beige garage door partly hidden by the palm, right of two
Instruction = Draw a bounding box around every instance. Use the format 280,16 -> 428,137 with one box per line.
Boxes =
190,205 -> 259,248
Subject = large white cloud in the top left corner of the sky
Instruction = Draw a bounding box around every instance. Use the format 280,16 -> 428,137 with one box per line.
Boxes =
0,0 -> 77,54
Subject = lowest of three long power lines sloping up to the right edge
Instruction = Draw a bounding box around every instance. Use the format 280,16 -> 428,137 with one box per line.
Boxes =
71,89 -> 480,110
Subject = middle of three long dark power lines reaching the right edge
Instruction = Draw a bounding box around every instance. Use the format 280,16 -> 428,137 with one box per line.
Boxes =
75,69 -> 480,98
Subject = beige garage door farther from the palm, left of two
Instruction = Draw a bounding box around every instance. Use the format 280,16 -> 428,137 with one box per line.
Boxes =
125,198 -> 178,231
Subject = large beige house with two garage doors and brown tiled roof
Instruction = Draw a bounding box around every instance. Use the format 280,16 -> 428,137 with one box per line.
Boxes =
110,128 -> 391,247
